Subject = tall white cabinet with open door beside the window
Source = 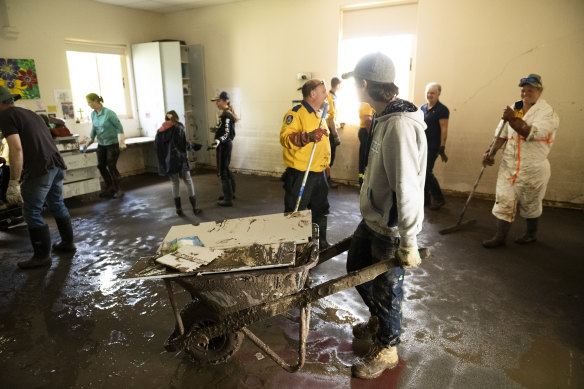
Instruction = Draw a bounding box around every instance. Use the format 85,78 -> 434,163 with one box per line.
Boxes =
132,42 -> 208,161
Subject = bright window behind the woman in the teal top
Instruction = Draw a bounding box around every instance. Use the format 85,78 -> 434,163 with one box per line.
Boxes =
67,42 -> 133,120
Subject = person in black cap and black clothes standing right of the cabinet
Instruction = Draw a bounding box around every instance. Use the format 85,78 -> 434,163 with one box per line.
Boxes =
211,91 -> 238,207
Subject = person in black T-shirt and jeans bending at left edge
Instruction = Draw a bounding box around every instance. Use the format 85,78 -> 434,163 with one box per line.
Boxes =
0,86 -> 76,269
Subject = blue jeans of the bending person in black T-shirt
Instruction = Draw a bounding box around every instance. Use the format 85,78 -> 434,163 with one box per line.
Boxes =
20,167 -> 69,228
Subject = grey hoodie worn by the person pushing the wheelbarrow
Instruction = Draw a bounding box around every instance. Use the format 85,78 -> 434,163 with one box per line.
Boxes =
360,99 -> 428,247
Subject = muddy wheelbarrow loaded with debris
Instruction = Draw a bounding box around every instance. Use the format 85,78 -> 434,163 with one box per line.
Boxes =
124,211 -> 428,372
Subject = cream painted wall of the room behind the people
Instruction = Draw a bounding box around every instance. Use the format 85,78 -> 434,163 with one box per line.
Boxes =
0,0 -> 584,204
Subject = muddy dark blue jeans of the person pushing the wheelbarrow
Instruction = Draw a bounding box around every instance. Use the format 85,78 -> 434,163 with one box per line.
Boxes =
347,221 -> 405,346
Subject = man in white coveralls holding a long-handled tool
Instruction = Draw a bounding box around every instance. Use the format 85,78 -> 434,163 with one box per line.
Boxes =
483,74 -> 560,248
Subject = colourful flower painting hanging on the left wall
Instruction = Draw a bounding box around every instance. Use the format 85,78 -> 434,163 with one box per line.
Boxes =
0,58 -> 41,99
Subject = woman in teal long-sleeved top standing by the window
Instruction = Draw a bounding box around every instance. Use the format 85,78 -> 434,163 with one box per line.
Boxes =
83,93 -> 126,198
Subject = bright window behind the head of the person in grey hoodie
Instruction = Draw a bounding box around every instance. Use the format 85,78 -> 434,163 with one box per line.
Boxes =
337,34 -> 414,125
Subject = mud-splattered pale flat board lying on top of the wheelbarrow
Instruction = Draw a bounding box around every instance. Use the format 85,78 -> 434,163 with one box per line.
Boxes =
158,210 -> 312,254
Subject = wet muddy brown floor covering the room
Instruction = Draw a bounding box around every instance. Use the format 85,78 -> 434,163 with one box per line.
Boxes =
0,171 -> 584,389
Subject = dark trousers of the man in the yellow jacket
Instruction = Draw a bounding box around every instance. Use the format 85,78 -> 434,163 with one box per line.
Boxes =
282,168 -> 329,220
